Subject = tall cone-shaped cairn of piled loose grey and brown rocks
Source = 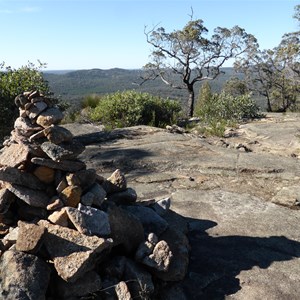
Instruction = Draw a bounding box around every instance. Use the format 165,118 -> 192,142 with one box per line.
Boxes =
0,91 -> 189,300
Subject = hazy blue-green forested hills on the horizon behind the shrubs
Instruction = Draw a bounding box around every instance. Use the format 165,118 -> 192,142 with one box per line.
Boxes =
44,68 -> 241,105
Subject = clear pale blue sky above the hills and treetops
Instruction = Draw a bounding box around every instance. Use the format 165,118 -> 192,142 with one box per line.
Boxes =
0,0 -> 300,70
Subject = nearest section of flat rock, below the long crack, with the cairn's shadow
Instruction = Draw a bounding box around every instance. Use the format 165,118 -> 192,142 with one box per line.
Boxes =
172,190 -> 300,300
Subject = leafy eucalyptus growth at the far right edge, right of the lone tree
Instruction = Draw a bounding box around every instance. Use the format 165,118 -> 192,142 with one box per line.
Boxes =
235,5 -> 300,111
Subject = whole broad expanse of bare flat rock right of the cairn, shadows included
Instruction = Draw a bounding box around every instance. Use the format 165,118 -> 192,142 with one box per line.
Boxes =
63,114 -> 300,300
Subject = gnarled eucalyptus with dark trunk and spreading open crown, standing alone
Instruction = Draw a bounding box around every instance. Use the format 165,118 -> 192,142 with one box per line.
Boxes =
143,16 -> 256,117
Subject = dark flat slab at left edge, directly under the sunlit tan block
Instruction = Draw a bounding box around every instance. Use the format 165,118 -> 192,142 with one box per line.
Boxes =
0,167 -> 45,190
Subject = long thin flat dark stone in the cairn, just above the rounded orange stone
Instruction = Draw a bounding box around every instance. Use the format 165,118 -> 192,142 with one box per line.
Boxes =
31,157 -> 86,172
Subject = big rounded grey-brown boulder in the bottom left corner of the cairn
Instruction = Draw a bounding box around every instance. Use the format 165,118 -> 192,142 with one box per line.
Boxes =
0,251 -> 50,300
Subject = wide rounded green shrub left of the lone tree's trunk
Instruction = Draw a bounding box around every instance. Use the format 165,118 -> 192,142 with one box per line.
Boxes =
85,90 -> 181,128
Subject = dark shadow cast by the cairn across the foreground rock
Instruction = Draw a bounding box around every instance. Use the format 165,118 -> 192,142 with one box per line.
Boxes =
183,218 -> 300,300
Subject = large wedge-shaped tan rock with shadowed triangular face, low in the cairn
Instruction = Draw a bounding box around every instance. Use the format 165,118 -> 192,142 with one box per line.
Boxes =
38,220 -> 112,282
